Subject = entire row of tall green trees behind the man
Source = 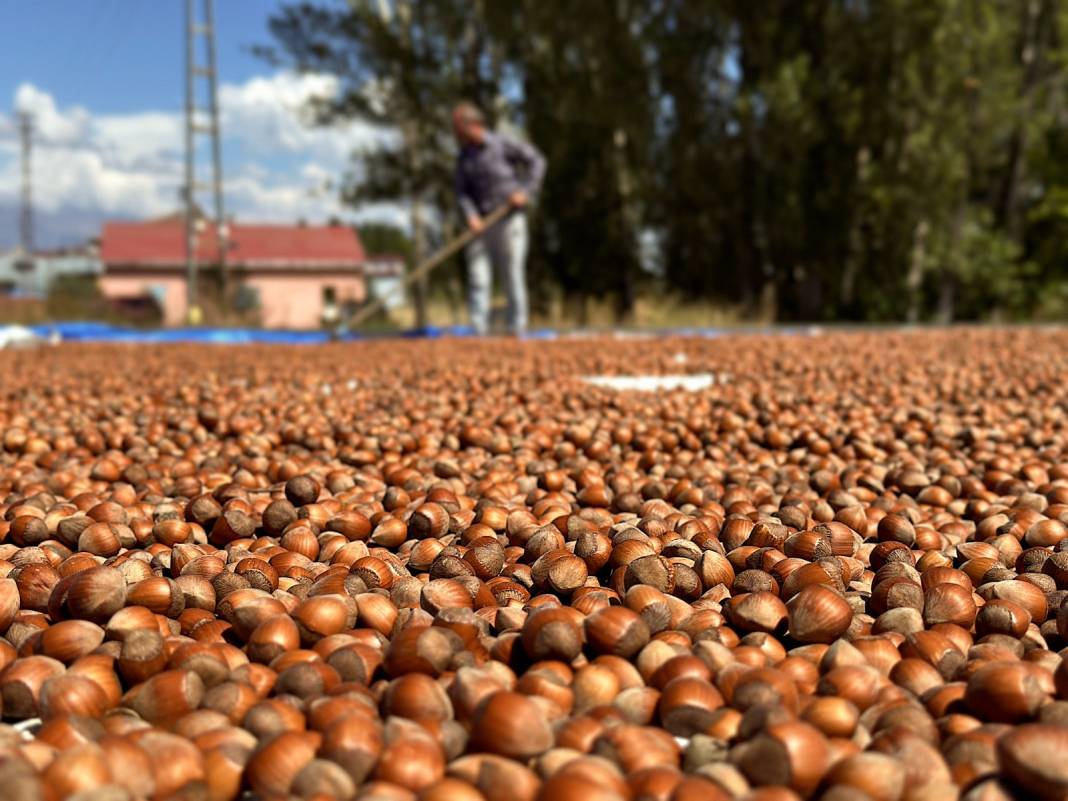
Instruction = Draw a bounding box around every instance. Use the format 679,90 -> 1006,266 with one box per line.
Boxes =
260,0 -> 1068,320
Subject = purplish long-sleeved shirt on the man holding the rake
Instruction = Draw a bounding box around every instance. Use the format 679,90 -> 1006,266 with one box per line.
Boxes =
455,130 -> 545,217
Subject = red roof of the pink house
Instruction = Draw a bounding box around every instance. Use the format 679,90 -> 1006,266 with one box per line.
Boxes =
100,219 -> 366,269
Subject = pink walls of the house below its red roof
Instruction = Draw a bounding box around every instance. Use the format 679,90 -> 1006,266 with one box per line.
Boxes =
99,272 -> 367,328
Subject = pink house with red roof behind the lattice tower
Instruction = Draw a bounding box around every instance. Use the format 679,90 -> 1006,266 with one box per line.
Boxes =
99,216 -> 404,329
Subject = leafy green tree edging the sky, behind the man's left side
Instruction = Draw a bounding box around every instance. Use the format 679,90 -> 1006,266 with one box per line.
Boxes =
260,0 -> 492,325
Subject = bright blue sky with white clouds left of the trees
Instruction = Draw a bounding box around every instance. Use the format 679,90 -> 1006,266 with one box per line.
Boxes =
0,0 -> 396,248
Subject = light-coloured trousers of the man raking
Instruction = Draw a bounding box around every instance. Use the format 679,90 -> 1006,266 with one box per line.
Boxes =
467,211 -> 528,334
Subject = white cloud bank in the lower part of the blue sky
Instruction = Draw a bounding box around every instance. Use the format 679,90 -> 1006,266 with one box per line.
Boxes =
0,73 -> 401,244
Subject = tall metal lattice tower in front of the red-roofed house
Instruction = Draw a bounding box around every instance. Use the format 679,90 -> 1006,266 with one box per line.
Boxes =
185,0 -> 230,325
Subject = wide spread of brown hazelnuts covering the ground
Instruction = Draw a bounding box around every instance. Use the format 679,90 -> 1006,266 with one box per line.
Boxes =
0,330 -> 1068,801
